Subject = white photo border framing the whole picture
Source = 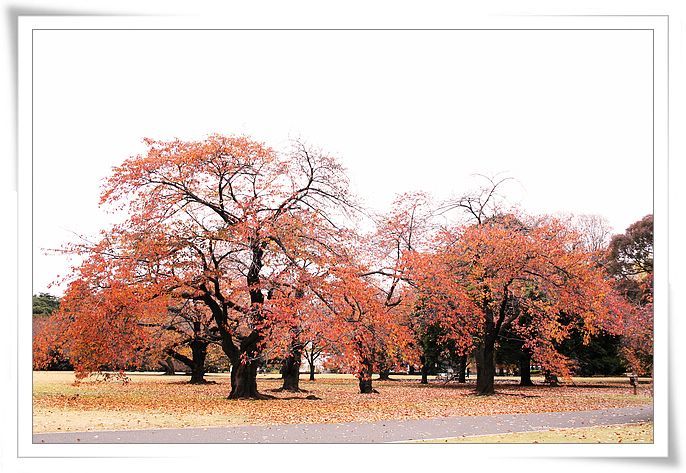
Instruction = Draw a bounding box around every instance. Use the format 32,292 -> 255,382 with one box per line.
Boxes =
17,16 -> 669,458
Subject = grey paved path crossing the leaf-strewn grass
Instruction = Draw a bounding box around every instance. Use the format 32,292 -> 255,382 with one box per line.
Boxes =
33,405 -> 653,443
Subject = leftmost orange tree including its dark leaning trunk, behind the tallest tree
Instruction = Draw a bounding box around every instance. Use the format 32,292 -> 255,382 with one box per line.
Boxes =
35,235 -> 226,383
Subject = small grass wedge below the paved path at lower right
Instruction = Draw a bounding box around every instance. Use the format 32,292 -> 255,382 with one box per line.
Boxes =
416,422 -> 653,443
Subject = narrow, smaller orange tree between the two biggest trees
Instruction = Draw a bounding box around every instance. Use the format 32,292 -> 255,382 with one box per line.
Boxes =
294,212 -> 415,394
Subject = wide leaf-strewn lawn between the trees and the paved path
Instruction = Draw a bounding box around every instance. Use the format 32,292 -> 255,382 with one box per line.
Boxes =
33,371 -> 652,433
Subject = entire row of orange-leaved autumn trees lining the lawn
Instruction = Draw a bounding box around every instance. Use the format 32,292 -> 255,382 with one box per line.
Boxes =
34,135 -> 652,398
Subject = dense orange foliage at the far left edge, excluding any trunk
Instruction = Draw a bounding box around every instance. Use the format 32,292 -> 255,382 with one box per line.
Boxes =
34,232 -> 175,378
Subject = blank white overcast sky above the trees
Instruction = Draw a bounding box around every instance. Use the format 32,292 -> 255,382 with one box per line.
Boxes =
33,31 -> 653,294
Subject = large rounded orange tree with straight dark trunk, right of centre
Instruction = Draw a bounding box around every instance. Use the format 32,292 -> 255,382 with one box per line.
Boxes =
413,215 -> 622,395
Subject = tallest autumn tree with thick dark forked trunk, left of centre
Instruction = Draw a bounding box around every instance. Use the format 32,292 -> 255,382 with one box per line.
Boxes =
60,135 -> 353,398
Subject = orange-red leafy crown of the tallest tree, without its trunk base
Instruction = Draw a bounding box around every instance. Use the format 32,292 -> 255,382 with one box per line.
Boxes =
50,135 -> 366,388
